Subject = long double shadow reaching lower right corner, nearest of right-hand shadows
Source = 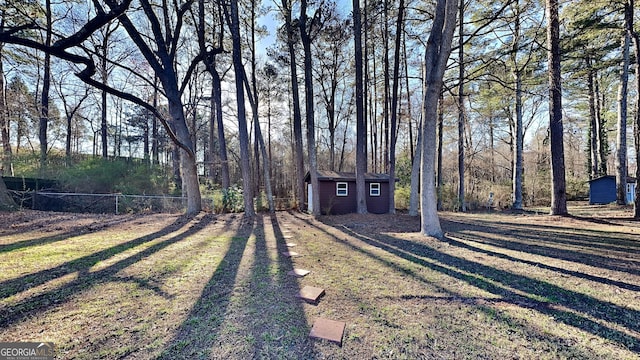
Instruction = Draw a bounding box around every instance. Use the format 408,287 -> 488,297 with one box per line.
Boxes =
336,226 -> 640,352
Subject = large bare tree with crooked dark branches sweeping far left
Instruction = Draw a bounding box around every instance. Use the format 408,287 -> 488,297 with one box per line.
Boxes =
0,0 -> 202,214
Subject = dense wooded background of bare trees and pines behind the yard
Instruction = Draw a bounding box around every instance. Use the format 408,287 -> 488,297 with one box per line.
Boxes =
0,0 -> 640,219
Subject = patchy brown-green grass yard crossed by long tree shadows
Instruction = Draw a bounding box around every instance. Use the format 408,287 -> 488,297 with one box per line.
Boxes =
0,205 -> 640,359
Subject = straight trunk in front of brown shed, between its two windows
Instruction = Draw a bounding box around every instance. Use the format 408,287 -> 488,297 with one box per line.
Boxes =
353,0 -> 368,214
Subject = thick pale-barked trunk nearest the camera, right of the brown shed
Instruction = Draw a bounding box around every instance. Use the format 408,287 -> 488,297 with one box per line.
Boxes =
420,0 -> 458,237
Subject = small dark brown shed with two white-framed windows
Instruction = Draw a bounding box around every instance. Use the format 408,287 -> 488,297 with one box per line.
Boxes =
305,170 -> 396,215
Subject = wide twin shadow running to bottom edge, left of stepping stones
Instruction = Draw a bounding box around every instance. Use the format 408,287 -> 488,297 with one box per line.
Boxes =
159,214 -> 314,359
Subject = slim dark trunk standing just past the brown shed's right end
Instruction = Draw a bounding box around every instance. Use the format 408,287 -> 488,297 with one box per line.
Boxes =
389,0 -> 404,214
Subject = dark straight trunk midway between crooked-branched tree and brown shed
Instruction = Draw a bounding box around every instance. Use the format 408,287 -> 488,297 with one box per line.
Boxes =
231,1 -> 255,217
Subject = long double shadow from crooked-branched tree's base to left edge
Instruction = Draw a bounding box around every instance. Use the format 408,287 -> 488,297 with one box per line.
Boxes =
0,214 -> 214,327
